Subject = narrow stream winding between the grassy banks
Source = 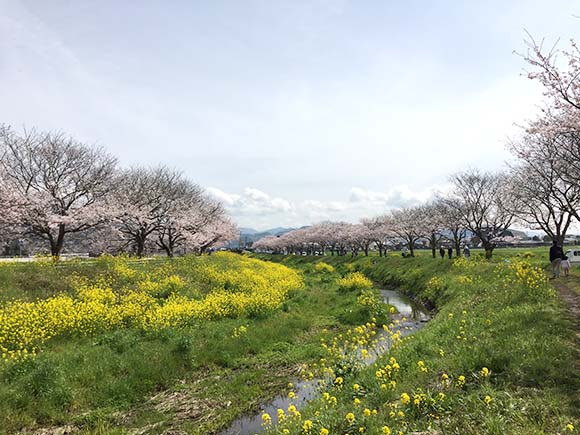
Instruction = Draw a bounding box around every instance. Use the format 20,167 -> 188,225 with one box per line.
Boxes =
219,290 -> 429,435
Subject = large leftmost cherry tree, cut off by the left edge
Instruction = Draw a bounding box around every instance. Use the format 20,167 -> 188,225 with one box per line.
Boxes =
0,126 -> 117,258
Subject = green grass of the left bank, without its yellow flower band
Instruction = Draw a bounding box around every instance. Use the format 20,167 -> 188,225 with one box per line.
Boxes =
0,254 -> 380,434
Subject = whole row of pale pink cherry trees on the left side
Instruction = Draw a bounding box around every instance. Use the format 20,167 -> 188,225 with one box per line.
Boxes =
0,126 -> 237,257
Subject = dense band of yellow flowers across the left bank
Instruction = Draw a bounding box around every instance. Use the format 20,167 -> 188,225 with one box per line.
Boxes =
0,253 -> 302,360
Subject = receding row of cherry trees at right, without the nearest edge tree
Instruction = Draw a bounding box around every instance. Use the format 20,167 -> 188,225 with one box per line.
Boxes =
254,170 -> 548,258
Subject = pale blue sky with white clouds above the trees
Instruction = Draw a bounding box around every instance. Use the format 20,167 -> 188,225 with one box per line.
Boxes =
0,0 -> 580,229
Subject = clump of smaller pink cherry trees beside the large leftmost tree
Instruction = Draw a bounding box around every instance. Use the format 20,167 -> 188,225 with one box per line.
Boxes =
115,166 -> 235,257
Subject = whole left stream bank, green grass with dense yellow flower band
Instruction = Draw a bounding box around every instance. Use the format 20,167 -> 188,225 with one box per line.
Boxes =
0,254 -> 380,434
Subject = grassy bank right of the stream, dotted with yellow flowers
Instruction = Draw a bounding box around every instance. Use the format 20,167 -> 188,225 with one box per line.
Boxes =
260,251 -> 580,435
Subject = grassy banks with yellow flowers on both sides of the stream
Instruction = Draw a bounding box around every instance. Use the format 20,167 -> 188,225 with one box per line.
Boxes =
0,250 -> 580,435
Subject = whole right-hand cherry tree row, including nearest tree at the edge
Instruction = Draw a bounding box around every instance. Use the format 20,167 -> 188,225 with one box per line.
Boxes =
254,38 -> 580,258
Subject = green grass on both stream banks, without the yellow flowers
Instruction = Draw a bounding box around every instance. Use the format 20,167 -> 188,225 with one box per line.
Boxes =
0,248 -> 580,435
